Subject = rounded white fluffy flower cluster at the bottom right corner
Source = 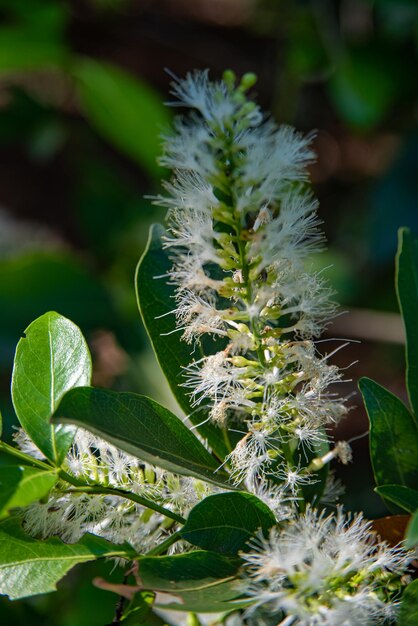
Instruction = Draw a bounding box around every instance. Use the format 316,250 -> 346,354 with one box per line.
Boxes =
242,509 -> 407,626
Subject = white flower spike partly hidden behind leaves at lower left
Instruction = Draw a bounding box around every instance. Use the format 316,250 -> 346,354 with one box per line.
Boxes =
15,428 -> 214,553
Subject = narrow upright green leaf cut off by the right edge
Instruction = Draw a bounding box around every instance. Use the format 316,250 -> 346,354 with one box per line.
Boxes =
396,228 -> 418,416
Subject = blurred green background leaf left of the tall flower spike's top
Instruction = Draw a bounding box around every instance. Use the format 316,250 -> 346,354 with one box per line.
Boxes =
73,58 -> 170,176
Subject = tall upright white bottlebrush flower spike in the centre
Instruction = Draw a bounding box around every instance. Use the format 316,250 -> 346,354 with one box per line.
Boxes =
156,72 -> 347,497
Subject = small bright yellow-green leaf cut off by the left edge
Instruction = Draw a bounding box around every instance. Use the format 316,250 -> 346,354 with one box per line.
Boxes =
0,465 -> 58,518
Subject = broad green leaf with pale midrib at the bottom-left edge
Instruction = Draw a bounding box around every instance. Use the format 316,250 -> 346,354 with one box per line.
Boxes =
0,518 -> 134,600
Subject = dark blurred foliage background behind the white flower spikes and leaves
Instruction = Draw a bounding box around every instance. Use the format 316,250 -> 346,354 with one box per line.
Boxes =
0,0 -> 418,626
